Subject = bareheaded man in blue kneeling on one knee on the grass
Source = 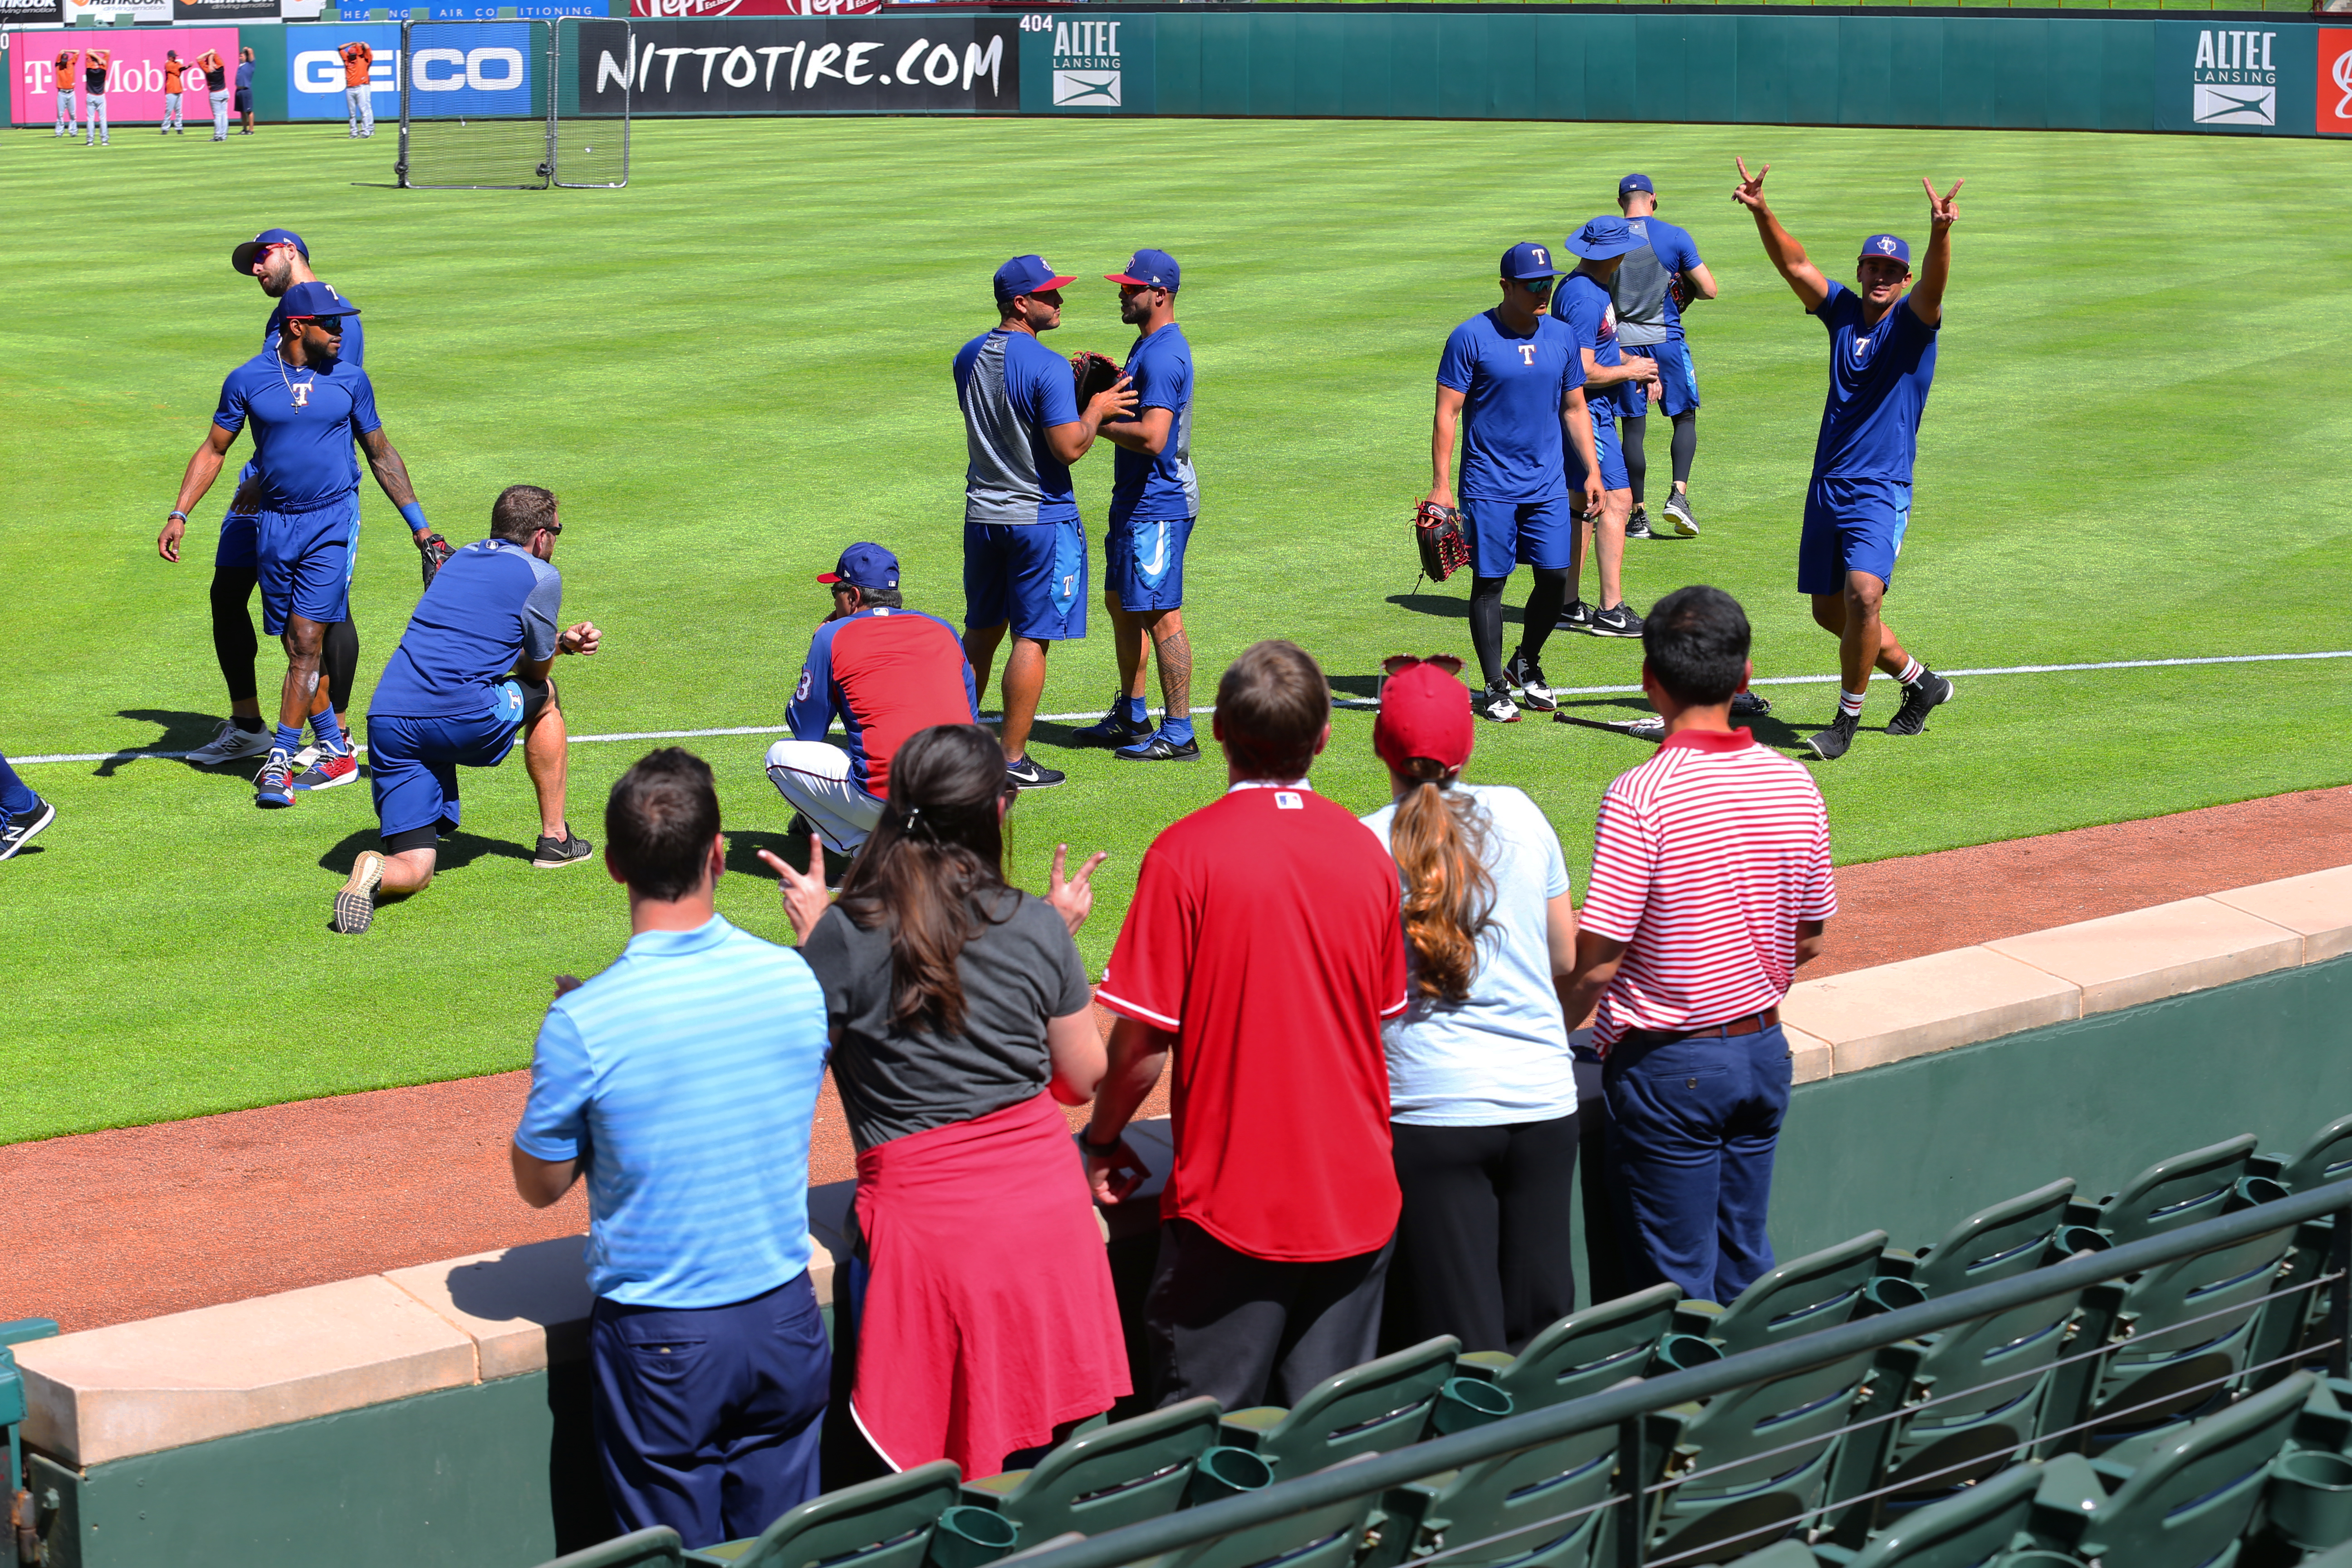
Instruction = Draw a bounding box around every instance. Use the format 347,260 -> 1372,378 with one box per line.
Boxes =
334,484 -> 604,936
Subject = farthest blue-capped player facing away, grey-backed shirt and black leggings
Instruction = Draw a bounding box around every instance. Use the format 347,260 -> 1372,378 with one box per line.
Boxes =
1609,174 -> 1715,539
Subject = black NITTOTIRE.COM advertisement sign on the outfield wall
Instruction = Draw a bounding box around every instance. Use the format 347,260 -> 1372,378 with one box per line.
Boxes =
578,16 -> 1021,115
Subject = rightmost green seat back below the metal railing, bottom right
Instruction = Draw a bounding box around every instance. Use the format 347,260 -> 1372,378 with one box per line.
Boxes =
2044,1373 -> 2317,1568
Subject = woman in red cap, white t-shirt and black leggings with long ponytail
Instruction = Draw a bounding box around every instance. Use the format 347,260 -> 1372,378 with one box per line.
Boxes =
1364,656 -> 1576,1354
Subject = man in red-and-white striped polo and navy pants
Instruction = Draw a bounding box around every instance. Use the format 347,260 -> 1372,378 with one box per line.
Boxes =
1567,588 -> 1837,1303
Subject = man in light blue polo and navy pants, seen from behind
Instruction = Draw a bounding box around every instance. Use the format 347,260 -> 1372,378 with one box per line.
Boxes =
513,745 -> 833,1547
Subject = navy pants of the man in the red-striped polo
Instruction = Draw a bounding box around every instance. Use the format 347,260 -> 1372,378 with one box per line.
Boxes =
1602,1025 -> 1790,1305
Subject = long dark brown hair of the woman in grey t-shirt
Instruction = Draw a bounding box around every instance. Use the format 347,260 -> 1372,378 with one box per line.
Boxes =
840,724 -> 1014,1034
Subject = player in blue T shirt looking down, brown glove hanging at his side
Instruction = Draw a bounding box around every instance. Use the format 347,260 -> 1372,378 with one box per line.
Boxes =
1430,242 -> 1602,724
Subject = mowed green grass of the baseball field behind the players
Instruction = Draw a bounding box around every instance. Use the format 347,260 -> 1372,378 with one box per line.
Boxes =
0,120 -> 2352,1140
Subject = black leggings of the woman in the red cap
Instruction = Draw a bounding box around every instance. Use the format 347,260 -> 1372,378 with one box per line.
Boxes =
1381,1112 -> 1576,1354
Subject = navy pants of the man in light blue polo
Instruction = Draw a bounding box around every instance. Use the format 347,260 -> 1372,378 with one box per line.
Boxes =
588,1272 -> 833,1547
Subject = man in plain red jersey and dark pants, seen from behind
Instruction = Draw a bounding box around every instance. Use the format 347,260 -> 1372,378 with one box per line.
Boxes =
1084,642 -> 1404,1411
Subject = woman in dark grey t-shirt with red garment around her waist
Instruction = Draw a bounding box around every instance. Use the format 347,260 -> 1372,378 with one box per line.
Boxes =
769,724 -> 1129,1476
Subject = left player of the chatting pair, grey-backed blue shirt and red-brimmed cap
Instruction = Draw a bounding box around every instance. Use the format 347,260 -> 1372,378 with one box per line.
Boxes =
955,256 -> 1136,790
